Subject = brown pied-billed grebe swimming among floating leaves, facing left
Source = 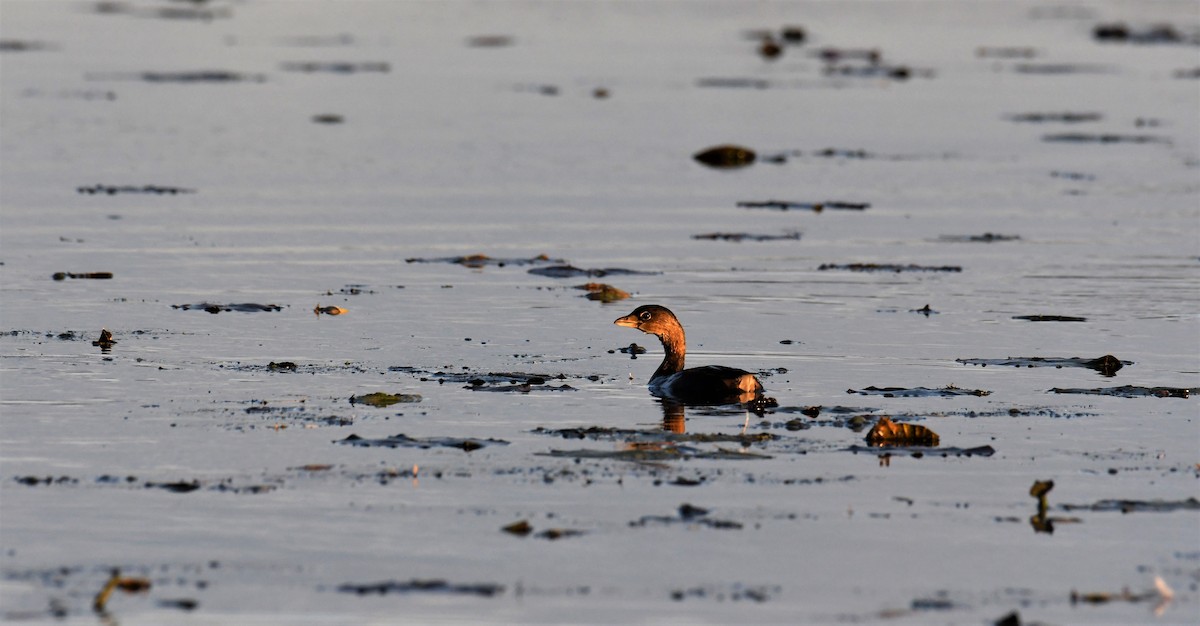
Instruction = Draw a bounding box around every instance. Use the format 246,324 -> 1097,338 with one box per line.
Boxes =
613,305 -> 762,404
